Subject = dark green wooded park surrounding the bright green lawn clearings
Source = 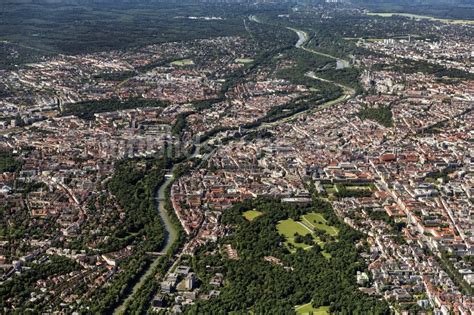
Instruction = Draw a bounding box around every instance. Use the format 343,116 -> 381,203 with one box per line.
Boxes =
189,197 -> 390,314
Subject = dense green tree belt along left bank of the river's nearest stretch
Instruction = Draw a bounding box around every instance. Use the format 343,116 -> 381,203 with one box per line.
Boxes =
83,157 -> 170,314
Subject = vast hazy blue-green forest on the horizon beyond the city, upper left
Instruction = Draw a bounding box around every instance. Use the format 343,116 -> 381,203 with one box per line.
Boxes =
0,0 -> 287,69
